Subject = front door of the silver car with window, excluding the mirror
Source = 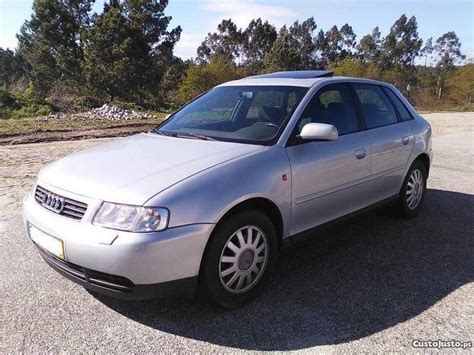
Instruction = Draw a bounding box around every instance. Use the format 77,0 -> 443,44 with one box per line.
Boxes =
286,84 -> 370,234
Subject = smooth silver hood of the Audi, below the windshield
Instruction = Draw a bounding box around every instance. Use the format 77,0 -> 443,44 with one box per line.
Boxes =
39,133 -> 263,205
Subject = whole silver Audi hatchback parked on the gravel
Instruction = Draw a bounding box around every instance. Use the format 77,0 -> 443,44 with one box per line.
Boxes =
23,71 -> 432,307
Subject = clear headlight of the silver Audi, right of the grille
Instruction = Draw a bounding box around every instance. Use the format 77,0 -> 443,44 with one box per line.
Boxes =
92,202 -> 169,232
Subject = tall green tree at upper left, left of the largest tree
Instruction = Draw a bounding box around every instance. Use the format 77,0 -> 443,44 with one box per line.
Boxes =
17,0 -> 94,95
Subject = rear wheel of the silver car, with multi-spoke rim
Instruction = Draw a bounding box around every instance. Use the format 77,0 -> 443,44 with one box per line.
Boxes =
397,160 -> 427,218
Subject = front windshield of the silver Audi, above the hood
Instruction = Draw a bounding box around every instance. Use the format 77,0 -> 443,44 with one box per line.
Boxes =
155,86 -> 307,144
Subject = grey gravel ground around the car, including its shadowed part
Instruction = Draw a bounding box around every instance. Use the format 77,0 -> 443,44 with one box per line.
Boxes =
0,113 -> 474,353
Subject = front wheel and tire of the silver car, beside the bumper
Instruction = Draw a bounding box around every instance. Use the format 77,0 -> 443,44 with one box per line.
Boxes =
200,210 -> 277,308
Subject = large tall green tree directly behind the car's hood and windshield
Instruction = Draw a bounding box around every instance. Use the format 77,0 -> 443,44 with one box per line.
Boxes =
83,0 -> 181,105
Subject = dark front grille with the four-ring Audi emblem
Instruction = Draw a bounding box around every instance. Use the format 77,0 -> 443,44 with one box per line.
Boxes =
35,185 -> 87,220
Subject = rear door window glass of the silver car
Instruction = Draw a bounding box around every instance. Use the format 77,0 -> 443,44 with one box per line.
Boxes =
353,84 -> 398,129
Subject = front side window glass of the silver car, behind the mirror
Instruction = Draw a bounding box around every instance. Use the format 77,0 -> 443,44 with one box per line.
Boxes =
298,84 -> 359,135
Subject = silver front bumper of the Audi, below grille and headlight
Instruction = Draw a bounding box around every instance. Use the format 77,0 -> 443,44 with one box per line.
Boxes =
23,187 -> 214,299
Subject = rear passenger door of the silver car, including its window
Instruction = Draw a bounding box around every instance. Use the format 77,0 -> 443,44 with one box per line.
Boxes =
351,83 -> 415,203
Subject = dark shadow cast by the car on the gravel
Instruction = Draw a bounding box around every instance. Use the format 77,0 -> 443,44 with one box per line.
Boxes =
94,189 -> 474,350
